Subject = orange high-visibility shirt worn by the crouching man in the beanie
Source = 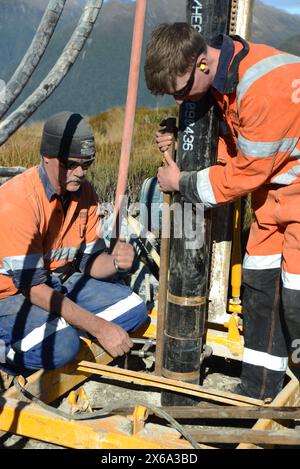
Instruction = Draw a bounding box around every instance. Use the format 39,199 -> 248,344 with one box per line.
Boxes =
0,166 -> 105,299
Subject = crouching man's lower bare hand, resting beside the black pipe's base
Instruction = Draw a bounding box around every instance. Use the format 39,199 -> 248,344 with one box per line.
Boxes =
92,317 -> 133,358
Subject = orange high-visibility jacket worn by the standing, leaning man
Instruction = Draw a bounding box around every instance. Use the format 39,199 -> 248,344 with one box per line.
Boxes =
180,41 -> 300,207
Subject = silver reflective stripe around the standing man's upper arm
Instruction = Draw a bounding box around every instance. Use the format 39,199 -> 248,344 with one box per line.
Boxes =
237,135 -> 298,158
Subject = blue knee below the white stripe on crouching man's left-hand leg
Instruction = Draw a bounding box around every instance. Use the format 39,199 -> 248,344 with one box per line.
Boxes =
14,326 -> 80,370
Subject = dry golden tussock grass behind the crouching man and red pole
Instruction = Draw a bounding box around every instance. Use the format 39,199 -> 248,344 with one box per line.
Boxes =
0,106 -> 178,202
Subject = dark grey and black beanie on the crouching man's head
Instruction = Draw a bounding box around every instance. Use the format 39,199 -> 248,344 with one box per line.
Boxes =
40,111 -> 96,159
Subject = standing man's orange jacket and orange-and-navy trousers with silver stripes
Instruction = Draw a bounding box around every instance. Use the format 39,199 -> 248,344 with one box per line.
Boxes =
180,37 -> 300,398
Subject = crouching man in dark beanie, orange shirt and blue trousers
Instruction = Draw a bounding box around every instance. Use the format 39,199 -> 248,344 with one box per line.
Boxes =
0,112 -> 147,370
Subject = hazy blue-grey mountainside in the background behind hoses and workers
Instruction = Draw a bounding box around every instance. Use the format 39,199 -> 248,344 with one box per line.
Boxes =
0,0 -> 300,120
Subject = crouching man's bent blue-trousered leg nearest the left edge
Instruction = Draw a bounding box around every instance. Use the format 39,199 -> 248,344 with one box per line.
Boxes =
0,294 -> 80,372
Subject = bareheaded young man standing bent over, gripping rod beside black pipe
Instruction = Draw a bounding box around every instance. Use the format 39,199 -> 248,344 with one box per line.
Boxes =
145,23 -> 300,399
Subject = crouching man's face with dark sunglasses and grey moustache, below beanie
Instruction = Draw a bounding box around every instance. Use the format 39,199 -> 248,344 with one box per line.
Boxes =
45,157 -> 95,192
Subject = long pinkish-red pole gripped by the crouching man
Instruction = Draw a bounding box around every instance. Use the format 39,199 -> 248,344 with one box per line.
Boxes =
113,0 -> 147,241
